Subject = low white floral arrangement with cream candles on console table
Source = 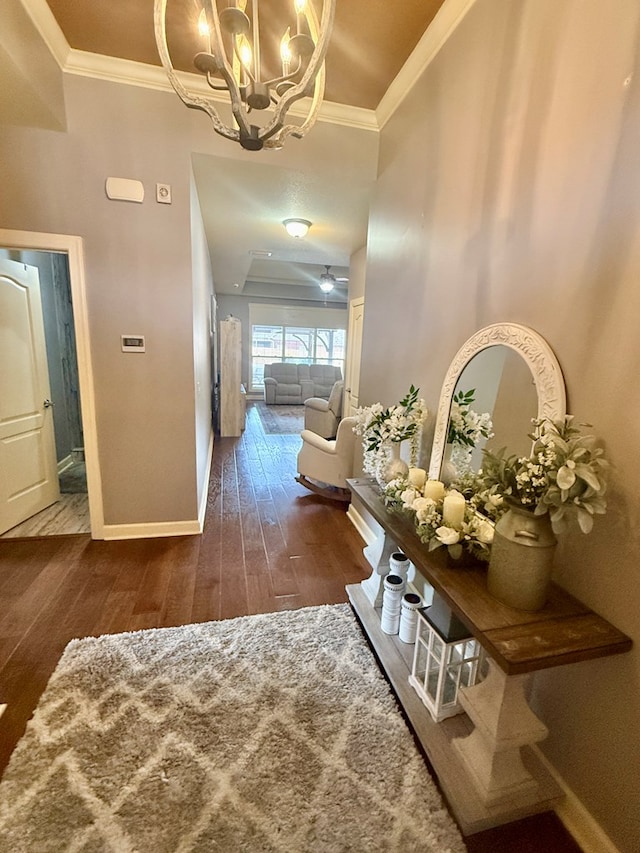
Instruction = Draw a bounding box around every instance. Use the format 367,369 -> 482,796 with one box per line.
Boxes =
384,478 -> 494,561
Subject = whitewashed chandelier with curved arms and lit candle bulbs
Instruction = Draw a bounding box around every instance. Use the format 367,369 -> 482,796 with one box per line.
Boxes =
154,0 -> 336,151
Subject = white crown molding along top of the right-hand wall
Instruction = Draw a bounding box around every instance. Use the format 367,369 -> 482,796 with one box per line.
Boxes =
376,0 -> 476,130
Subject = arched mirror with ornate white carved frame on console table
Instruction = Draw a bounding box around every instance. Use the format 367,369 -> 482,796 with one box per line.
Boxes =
429,323 -> 566,480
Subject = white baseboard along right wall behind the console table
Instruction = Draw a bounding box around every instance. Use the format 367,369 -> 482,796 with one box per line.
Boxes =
347,503 -> 620,853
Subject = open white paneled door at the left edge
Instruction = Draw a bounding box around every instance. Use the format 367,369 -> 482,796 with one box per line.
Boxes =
0,260 -> 60,534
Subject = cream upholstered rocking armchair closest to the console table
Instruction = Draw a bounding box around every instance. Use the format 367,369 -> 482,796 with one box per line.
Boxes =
296,417 -> 357,501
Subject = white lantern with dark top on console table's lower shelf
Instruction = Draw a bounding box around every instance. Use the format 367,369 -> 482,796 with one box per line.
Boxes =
409,593 -> 484,723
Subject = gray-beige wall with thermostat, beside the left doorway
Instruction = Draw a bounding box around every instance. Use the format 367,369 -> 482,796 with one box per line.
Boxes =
0,31 -> 378,525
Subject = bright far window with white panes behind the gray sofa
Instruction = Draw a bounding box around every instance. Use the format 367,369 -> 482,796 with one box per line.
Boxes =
250,325 -> 346,392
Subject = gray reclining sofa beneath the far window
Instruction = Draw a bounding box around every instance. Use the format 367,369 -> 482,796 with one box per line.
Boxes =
264,362 -> 342,406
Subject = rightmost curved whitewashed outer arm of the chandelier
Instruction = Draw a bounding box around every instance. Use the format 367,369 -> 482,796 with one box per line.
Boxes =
259,0 -> 336,141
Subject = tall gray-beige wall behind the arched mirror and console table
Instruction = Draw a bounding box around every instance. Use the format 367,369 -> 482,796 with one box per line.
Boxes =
360,0 -> 640,853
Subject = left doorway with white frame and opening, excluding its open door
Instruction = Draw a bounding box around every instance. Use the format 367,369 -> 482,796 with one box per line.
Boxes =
0,229 -> 104,539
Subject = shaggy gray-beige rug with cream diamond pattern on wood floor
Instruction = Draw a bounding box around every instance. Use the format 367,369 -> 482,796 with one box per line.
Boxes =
0,605 -> 465,853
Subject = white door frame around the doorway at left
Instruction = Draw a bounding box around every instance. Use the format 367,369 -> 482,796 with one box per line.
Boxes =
0,228 -> 104,539
